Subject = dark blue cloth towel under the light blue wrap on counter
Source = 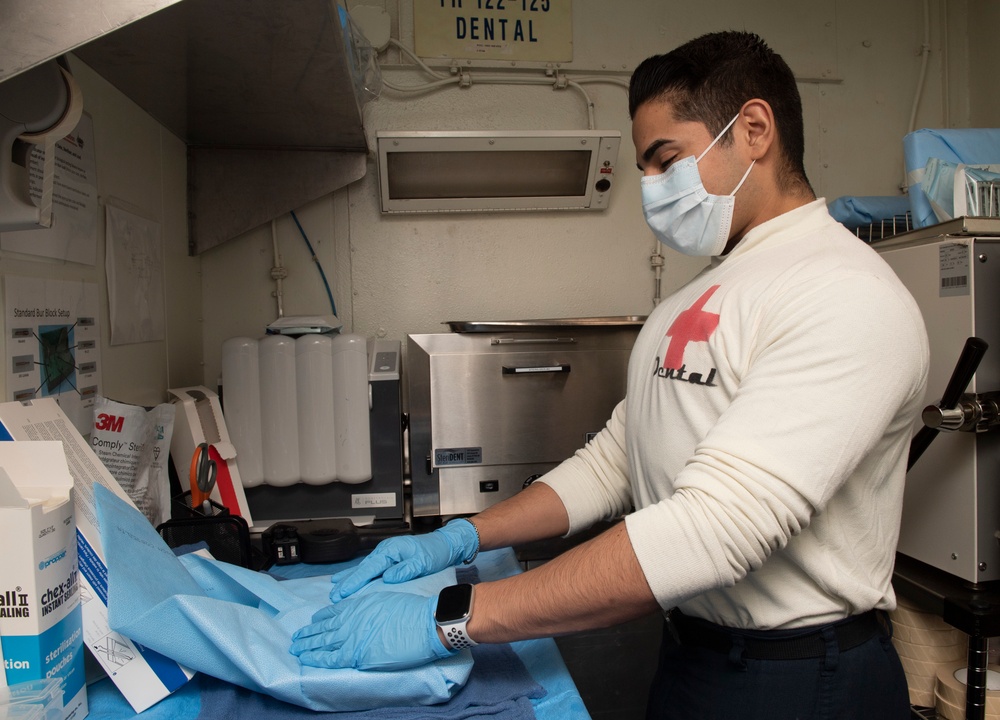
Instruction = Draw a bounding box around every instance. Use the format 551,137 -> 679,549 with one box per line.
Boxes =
197,645 -> 545,720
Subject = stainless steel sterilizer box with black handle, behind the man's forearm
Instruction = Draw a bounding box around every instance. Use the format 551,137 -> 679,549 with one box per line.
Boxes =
407,317 -> 642,516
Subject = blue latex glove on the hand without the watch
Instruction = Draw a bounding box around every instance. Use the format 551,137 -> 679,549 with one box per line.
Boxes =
330,519 -> 479,603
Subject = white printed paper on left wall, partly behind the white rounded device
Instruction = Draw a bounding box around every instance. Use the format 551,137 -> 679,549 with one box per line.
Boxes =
0,113 -> 100,265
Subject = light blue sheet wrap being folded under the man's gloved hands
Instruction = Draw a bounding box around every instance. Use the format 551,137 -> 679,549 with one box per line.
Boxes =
94,485 -> 472,712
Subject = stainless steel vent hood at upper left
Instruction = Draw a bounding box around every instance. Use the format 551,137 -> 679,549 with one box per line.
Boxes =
0,0 -> 367,253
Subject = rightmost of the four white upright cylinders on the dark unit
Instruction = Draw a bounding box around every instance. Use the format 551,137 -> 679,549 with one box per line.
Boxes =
333,335 -> 372,483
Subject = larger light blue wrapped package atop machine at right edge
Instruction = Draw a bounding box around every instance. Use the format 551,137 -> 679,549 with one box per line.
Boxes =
903,128 -> 1000,227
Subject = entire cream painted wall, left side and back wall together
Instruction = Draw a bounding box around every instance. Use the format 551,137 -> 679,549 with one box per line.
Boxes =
0,0 -> 988,403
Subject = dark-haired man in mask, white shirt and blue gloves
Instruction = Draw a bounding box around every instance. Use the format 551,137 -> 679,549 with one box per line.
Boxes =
292,32 -> 928,720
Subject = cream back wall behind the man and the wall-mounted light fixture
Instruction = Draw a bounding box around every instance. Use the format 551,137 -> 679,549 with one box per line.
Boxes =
202,0 -> 984,390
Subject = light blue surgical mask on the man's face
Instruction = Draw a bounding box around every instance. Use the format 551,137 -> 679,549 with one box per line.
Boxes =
642,114 -> 757,257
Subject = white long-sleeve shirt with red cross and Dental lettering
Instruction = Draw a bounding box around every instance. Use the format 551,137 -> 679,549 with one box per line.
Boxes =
541,199 -> 928,629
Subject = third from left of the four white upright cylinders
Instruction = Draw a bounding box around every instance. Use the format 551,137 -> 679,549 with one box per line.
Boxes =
295,335 -> 337,485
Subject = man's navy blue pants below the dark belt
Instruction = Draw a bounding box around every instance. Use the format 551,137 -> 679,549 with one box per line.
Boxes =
646,619 -> 910,720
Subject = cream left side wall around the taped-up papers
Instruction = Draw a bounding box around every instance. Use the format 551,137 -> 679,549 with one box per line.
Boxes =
0,58 -> 203,405
